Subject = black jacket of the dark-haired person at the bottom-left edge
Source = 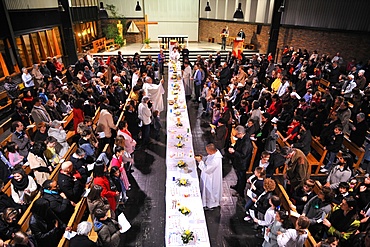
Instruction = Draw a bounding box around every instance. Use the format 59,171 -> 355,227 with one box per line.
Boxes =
30,214 -> 63,247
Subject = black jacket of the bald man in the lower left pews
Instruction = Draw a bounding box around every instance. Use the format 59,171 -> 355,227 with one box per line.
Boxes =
58,173 -> 84,203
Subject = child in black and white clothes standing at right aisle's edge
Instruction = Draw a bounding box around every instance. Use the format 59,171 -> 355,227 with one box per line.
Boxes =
244,167 -> 265,221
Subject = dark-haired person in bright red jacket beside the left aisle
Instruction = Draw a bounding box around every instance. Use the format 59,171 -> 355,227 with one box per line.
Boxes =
93,160 -> 119,211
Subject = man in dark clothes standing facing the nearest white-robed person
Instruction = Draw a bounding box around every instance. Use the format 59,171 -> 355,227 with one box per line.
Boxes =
228,125 -> 253,198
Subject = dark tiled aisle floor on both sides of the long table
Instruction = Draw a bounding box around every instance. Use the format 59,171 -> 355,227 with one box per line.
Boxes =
121,68 -> 262,247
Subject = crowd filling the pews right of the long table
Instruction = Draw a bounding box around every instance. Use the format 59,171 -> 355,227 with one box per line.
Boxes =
191,47 -> 370,246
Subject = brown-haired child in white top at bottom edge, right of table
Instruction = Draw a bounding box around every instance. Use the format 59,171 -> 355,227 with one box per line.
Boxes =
276,216 -> 310,247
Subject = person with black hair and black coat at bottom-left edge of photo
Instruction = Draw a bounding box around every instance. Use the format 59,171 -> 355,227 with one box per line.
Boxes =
29,198 -> 64,247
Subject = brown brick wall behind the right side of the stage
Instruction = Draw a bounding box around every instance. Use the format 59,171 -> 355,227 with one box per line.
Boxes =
199,19 -> 370,62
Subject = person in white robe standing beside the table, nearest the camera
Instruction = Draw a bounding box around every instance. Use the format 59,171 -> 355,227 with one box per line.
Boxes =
195,143 -> 222,210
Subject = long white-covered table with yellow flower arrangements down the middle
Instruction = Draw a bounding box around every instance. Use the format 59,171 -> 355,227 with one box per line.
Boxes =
165,62 -> 210,247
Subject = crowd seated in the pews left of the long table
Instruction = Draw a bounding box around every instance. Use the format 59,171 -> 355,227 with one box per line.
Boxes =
0,53 -> 163,246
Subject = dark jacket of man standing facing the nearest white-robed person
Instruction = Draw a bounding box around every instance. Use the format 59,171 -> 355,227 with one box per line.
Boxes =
232,135 -> 253,171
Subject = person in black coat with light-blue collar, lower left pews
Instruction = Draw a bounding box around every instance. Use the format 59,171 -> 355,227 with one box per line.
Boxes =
41,179 -> 74,224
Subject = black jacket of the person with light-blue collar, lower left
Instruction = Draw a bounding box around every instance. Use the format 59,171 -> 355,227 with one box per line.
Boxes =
42,191 -> 74,224
